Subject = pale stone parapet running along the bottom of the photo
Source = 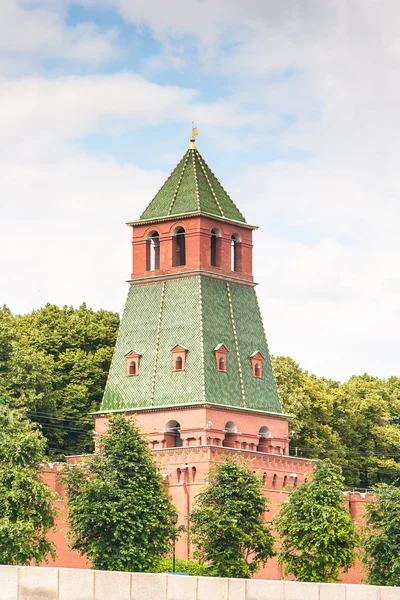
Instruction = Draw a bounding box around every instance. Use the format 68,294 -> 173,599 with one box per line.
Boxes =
0,567 -> 400,600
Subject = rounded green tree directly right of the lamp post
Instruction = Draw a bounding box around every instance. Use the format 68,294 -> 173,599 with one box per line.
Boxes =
190,459 -> 274,578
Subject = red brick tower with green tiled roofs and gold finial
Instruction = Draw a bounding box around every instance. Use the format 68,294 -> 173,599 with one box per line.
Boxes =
96,138 -> 310,576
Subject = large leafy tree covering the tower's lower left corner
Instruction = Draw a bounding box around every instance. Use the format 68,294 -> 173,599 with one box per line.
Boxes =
63,415 -> 175,572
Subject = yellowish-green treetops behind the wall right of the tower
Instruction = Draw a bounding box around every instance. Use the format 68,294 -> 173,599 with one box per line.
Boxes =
273,356 -> 400,488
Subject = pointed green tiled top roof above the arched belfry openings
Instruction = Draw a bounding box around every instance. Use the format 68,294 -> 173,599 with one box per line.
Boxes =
140,148 -> 246,223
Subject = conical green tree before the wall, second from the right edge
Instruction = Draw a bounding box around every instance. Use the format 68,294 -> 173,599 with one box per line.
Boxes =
275,460 -> 357,581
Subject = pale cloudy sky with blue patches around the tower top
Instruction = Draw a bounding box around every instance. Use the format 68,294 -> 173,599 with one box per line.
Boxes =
0,0 -> 400,380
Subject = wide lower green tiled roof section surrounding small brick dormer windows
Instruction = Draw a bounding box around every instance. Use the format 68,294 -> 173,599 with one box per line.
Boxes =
101,276 -> 281,413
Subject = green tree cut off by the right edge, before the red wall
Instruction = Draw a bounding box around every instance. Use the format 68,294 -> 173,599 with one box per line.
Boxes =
362,483 -> 400,586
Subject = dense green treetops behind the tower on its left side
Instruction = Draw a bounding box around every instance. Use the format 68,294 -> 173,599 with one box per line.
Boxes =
0,304 -> 119,457
